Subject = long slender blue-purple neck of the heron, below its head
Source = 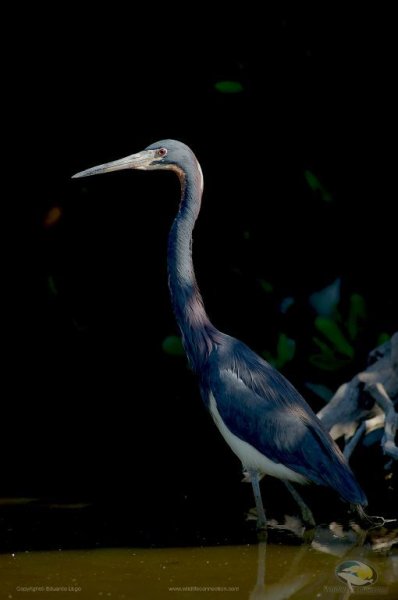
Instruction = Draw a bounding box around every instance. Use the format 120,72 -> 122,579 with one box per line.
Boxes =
167,163 -> 216,371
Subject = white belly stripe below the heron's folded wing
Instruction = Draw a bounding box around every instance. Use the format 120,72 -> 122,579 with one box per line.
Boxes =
210,394 -> 306,483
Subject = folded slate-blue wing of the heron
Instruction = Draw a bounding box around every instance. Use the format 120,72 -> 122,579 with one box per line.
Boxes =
208,336 -> 366,504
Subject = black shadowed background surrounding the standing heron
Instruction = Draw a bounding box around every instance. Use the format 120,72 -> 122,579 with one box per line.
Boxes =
1,6 -> 397,543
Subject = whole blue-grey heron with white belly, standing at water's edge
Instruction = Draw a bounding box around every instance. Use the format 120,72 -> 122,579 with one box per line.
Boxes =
73,140 -> 367,528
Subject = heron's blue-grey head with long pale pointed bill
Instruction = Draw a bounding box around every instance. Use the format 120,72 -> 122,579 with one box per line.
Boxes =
73,140 -> 201,183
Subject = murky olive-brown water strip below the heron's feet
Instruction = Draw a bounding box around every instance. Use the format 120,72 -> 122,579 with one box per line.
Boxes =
0,523 -> 398,600
